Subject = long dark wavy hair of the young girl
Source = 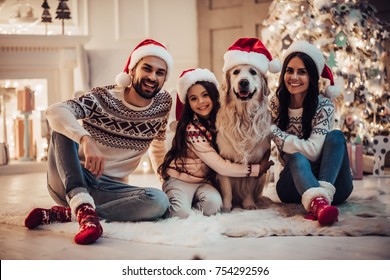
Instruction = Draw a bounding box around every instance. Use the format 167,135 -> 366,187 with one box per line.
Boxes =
158,81 -> 219,180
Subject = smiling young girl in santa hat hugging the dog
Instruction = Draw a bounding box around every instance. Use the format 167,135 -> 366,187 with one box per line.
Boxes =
159,68 -> 273,218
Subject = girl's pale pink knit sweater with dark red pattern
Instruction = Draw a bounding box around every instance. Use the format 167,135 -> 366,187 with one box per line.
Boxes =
167,116 -> 260,183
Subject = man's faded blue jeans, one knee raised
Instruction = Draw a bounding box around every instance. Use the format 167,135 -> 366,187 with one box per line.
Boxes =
47,131 -> 169,221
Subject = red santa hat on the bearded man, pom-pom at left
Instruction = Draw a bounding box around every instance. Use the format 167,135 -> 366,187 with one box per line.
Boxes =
115,39 -> 173,87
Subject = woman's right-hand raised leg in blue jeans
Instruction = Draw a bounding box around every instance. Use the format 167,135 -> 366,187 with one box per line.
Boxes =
318,130 -> 353,204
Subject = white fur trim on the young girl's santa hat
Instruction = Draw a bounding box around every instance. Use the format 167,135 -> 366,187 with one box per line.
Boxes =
177,68 -> 219,104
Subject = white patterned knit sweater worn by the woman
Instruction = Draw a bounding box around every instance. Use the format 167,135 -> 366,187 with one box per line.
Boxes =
270,95 -> 334,161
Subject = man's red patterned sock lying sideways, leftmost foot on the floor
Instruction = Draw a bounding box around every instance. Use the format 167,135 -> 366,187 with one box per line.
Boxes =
24,206 -> 71,229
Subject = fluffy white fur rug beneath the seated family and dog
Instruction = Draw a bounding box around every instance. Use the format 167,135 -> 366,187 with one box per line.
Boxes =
0,186 -> 390,247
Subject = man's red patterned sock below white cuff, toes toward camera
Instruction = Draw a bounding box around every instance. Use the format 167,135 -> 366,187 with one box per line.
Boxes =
74,203 -> 103,244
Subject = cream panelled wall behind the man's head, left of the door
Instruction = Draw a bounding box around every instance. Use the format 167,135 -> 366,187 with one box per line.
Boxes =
85,0 -> 198,89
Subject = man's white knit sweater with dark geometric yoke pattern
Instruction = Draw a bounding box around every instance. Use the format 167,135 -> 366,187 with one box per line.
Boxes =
46,86 -> 172,181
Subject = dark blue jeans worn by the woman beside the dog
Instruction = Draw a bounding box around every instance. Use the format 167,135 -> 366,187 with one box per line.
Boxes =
276,130 -> 353,204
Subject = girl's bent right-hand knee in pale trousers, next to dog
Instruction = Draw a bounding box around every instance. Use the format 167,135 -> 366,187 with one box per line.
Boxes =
194,184 -> 222,216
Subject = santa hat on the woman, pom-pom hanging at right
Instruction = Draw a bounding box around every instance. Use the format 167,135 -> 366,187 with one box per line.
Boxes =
284,41 -> 341,99
